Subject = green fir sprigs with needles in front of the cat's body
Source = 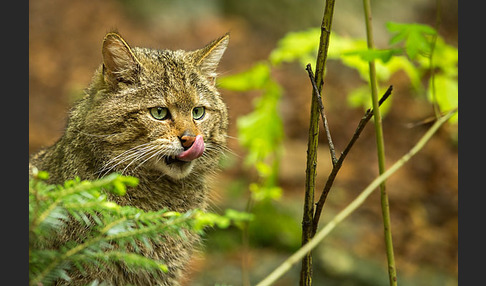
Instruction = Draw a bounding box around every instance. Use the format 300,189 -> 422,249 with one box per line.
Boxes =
29,171 -> 251,285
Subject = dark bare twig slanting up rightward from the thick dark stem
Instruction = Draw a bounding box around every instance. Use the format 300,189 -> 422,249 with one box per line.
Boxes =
313,85 -> 393,234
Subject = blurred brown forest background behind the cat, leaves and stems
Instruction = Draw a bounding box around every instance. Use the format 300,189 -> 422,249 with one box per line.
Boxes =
29,0 -> 458,285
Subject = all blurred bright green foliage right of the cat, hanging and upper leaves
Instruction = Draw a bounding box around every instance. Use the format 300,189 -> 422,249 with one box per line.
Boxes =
219,18 -> 458,286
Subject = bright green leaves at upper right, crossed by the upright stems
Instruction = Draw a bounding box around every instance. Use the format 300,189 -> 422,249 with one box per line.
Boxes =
264,22 -> 458,122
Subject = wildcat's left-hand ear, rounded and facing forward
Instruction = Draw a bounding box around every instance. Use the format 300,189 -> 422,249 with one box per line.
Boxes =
102,32 -> 141,86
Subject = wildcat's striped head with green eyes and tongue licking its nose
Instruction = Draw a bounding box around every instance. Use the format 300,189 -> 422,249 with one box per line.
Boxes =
84,32 -> 229,179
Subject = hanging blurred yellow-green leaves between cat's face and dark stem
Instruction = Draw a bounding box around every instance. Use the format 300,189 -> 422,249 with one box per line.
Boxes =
219,62 -> 283,201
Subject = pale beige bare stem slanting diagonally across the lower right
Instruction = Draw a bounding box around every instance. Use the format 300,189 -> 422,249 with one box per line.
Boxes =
256,109 -> 457,286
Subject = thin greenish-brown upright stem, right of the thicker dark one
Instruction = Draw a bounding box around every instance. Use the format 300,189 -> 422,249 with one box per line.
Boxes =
363,0 -> 397,285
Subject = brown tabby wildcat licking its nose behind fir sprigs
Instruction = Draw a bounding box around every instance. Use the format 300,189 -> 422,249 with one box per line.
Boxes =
29,32 -> 229,285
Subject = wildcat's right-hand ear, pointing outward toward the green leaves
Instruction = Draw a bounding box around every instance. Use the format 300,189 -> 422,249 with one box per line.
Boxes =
195,33 -> 229,84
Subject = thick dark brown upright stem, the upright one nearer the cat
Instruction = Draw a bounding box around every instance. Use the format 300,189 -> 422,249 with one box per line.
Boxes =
300,0 -> 334,285
